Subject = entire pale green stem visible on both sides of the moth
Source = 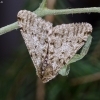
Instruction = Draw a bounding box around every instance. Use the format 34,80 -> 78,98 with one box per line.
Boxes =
0,6 -> 100,35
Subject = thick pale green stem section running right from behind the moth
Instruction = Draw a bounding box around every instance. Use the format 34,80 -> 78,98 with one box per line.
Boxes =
34,7 -> 100,17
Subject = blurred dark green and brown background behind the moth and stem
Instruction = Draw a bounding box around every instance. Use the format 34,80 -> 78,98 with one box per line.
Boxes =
0,0 -> 100,100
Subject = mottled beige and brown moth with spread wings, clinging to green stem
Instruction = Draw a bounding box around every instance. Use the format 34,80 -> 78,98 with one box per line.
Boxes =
17,10 -> 92,83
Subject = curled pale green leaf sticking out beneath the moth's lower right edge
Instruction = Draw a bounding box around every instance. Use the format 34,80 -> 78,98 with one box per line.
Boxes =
59,35 -> 92,76
